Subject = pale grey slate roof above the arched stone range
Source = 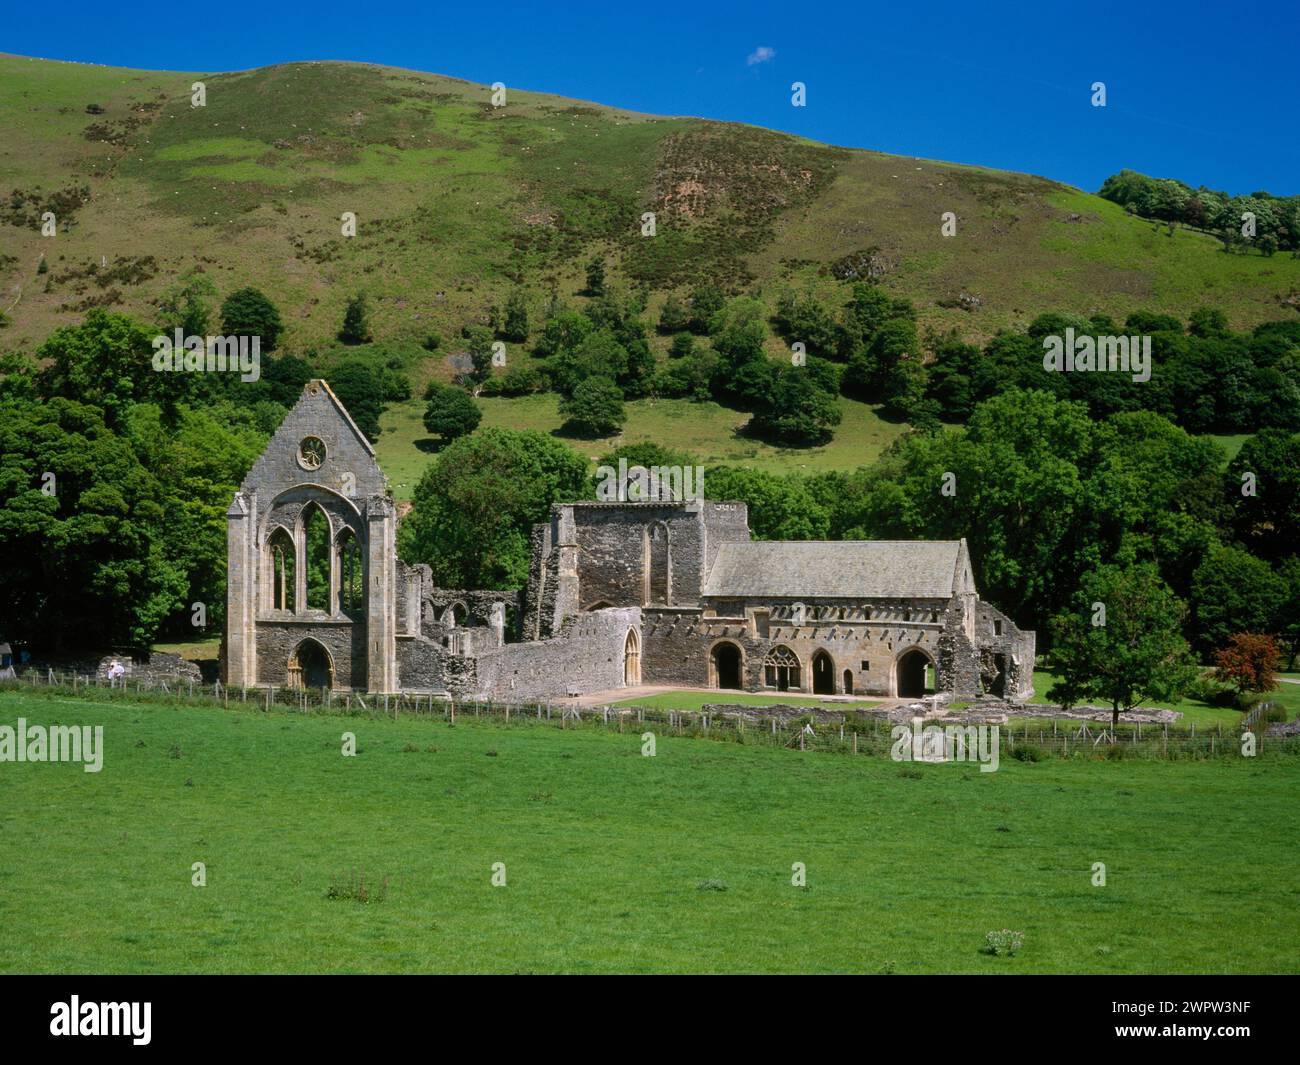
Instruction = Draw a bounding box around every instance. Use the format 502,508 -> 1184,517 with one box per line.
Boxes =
702,540 -> 962,599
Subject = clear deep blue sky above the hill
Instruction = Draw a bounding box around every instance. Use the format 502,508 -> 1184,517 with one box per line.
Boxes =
0,0 -> 1300,195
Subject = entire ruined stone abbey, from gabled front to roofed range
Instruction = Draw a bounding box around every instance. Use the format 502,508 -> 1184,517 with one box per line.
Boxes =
222,381 -> 1034,701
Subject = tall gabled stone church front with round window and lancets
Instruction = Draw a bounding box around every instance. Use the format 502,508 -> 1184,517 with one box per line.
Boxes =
225,380 -> 398,692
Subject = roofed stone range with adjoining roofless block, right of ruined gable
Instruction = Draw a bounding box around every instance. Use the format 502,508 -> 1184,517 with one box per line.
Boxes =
524,502 -> 1035,700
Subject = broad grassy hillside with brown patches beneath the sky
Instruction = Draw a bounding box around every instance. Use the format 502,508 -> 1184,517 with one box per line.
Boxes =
0,56 -> 1300,358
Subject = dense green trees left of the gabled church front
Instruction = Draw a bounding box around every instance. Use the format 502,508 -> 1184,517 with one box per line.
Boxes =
0,297 -> 410,651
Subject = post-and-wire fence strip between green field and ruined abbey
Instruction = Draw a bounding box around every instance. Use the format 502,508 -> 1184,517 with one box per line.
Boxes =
0,668 -> 1300,762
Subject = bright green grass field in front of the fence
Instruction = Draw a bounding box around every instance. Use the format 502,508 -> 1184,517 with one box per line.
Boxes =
0,692 -> 1300,973
